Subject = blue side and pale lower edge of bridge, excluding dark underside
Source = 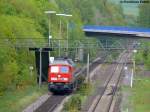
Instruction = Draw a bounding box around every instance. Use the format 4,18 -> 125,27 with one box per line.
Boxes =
83,25 -> 150,37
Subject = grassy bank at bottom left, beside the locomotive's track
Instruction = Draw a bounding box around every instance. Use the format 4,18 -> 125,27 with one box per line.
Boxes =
0,85 -> 47,112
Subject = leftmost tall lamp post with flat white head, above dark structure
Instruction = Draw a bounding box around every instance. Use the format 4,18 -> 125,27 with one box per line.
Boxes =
45,11 -> 56,46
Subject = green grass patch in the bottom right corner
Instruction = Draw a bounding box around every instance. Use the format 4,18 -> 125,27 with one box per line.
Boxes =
131,77 -> 150,112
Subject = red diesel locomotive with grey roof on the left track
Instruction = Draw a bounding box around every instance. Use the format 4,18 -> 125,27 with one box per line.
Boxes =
48,59 -> 76,92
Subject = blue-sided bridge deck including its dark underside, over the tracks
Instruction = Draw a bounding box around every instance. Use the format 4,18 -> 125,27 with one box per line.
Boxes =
83,25 -> 150,39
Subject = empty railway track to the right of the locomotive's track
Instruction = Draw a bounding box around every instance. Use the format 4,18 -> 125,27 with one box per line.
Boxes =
88,52 -> 129,112
